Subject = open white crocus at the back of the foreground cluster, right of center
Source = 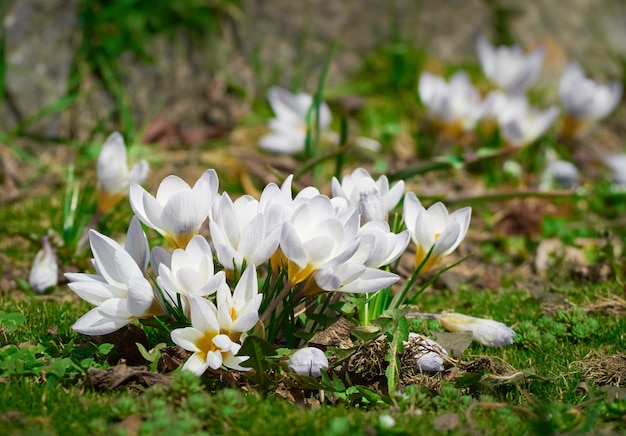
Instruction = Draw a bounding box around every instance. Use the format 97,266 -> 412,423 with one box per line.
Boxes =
331,168 -> 404,224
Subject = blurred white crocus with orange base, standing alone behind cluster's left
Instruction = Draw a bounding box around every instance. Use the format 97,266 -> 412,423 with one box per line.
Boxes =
97,132 -> 149,212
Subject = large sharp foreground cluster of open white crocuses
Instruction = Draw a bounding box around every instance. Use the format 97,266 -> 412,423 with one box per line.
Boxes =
66,168 -> 471,374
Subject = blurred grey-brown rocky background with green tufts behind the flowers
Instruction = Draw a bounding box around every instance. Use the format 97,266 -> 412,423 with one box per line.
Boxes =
0,0 -> 626,141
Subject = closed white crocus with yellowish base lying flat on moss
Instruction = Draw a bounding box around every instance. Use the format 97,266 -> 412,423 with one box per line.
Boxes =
436,313 -> 515,347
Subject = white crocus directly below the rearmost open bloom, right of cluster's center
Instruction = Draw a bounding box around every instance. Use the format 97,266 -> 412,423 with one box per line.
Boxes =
350,220 -> 411,268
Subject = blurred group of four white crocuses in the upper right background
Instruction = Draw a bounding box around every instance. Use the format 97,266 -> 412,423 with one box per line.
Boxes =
418,36 -> 622,146
